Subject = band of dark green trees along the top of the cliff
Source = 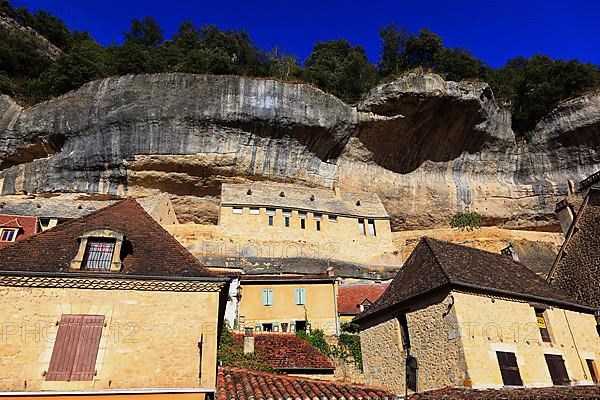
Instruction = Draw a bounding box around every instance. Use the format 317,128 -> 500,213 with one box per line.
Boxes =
0,0 -> 600,136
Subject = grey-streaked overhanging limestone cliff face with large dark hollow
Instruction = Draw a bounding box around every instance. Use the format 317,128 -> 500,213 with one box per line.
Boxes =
0,74 -> 600,229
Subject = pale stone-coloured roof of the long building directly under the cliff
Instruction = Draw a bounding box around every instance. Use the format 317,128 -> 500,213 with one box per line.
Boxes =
221,182 -> 389,218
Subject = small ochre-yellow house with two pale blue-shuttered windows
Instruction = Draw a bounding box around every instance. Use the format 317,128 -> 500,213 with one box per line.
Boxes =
237,274 -> 339,335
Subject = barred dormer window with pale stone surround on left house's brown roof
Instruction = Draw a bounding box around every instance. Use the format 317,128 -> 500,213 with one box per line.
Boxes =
71,229 -> 125,272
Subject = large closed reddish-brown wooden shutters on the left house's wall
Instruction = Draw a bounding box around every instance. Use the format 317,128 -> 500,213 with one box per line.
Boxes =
45,315 -> 104,381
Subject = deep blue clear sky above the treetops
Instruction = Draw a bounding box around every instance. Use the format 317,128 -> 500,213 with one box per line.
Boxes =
12,0 -> 600,67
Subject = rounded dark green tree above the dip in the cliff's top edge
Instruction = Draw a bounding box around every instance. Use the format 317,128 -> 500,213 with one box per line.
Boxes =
303,40 -> 377,102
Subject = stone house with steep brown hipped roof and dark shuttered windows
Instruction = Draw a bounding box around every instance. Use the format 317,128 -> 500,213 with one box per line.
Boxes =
355,238 -> 600,393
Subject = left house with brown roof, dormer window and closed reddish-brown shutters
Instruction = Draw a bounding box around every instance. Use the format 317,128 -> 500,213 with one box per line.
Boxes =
0,199 -> 228,399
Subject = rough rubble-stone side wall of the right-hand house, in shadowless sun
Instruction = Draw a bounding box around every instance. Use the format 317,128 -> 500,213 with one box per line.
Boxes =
360,299 -> 468,394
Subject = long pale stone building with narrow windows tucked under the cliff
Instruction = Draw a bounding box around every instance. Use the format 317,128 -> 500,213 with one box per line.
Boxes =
219,183 -> 395,262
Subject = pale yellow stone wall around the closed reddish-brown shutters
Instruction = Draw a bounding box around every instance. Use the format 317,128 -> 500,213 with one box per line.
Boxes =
0,286 -> 219,391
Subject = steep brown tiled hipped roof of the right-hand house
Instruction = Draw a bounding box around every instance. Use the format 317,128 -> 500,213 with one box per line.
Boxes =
357,237 -> 593,320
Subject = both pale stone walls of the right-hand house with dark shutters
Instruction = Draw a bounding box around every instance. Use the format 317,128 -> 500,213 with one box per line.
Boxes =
360,291 -> 600,393
